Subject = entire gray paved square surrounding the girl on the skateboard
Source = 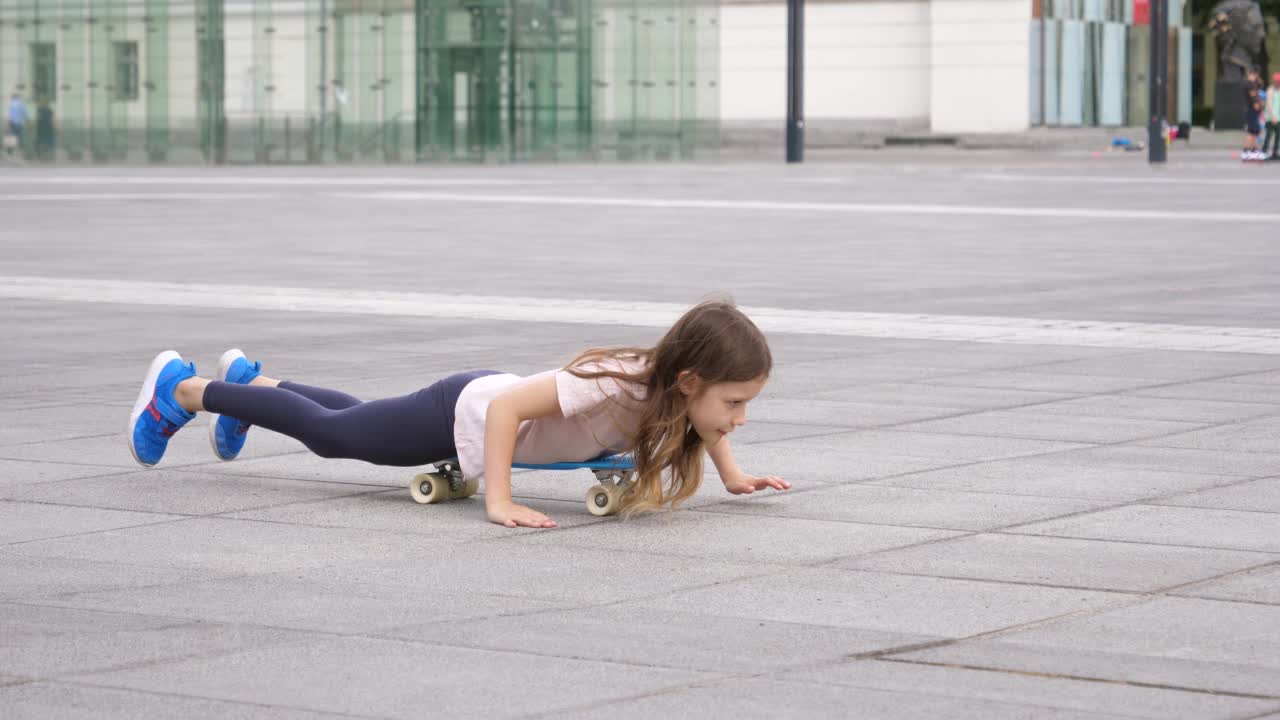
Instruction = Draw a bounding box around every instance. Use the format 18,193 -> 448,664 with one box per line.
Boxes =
0,147 -> 1280,720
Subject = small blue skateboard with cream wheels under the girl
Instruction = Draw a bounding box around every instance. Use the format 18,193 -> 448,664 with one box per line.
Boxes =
408,455 -> 636,518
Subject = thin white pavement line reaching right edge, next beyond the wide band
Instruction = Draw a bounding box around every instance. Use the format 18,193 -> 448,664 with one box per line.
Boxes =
328,192 -> 1280,223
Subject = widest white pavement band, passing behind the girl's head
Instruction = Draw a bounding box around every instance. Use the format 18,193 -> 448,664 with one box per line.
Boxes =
0,275 -> 1280,355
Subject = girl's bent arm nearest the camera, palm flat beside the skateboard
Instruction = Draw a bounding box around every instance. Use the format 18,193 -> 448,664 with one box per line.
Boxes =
484,375 -> 561,528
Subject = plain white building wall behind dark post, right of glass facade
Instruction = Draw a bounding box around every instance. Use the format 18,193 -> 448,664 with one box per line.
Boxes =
721,0 -> 1032,133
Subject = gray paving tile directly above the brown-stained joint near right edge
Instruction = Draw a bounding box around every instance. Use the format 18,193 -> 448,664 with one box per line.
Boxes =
835,534 -> 1280,592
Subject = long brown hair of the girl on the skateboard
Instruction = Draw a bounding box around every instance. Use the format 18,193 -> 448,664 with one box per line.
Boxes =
564,300 -> 773,516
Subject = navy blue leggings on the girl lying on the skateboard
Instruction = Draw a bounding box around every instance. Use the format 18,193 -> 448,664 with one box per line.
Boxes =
205,370 -> 498,468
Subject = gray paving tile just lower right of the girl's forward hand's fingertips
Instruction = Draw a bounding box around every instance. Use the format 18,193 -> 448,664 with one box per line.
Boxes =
704,484 -> 1106,530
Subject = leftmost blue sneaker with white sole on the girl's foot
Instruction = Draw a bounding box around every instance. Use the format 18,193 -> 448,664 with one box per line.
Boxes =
128,350 -> 196,468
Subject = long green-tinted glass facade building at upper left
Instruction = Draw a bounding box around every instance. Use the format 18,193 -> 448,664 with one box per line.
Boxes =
0,0 -> 719,163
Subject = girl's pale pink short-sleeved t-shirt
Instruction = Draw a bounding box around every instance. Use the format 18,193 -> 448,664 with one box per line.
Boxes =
453,360 -> 645,478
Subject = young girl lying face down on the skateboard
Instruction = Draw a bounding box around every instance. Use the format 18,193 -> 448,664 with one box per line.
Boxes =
128,301 -> 791,528
